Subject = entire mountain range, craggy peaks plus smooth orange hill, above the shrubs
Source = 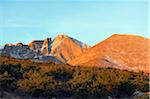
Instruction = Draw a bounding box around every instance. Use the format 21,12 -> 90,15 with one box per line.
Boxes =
1,34 -> 150,73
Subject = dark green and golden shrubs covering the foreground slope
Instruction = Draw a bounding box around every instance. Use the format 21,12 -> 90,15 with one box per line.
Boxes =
0,57 -> 149,98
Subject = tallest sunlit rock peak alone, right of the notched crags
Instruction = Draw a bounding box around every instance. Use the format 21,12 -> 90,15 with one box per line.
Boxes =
50,35 -> 89,63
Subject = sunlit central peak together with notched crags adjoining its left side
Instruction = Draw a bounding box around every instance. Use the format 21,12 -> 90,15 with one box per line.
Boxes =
28,34 -> 89,63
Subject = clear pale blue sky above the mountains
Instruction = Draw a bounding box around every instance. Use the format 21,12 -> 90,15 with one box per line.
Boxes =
0,0 -> 148,45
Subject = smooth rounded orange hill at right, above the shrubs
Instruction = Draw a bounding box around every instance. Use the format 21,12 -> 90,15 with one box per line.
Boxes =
68,34 -> 150,72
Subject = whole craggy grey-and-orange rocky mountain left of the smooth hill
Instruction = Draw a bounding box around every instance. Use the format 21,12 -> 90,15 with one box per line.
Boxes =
1,35 -> 89,63
